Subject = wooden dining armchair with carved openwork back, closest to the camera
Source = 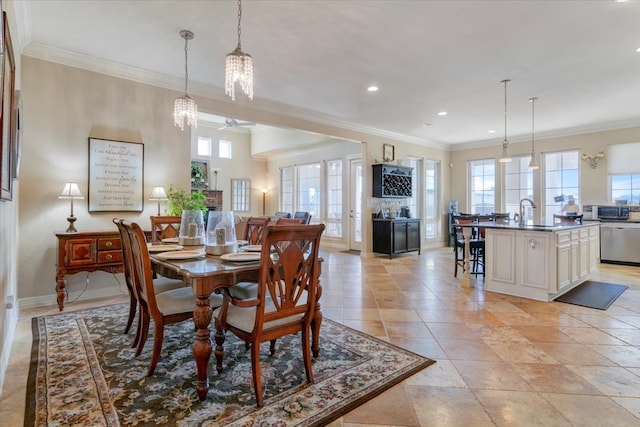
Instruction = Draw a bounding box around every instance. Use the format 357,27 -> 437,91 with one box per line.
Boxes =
213,224 -> 324,407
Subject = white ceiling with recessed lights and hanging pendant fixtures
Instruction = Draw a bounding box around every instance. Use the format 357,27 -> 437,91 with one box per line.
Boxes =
16,0 -> 640,149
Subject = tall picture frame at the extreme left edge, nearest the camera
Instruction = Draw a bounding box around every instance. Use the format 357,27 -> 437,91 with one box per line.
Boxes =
0,12 -> 15,200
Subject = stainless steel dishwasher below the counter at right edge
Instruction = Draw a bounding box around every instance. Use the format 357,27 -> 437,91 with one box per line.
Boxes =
600,222 -> 640,263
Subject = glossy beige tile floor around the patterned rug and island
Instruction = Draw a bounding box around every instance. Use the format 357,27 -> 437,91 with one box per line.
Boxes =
0,248 -> 640,427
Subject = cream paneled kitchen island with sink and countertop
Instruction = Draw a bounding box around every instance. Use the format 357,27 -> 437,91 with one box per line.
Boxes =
461,222 -> 600,301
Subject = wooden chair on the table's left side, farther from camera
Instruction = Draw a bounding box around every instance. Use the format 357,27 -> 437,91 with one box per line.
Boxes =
113,218 -> 185,347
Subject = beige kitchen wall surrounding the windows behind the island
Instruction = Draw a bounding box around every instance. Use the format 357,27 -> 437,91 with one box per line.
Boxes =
450,127 -> 640,219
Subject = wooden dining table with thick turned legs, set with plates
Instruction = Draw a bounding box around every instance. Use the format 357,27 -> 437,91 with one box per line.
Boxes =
150,246 -> 322,400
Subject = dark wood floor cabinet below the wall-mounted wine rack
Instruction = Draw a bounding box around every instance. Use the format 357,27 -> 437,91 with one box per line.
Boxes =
373,218 -> 420,258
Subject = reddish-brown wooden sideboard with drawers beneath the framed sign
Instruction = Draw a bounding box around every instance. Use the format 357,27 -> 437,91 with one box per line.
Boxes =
55,230 -> 123,311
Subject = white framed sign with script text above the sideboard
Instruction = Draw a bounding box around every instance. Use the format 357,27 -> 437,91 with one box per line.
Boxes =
89,138 -> 144,212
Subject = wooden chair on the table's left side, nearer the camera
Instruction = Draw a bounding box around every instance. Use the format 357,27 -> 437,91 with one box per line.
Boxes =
120,220 -> 222,376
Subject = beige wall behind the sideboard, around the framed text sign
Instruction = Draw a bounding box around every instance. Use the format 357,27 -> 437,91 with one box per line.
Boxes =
18,57 -> 191,306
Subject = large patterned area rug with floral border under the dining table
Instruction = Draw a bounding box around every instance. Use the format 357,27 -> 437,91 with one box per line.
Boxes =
25,305 -> 434,426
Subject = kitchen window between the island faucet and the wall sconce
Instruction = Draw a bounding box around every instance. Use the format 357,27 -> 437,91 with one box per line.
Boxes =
544,151 -> 580,224
